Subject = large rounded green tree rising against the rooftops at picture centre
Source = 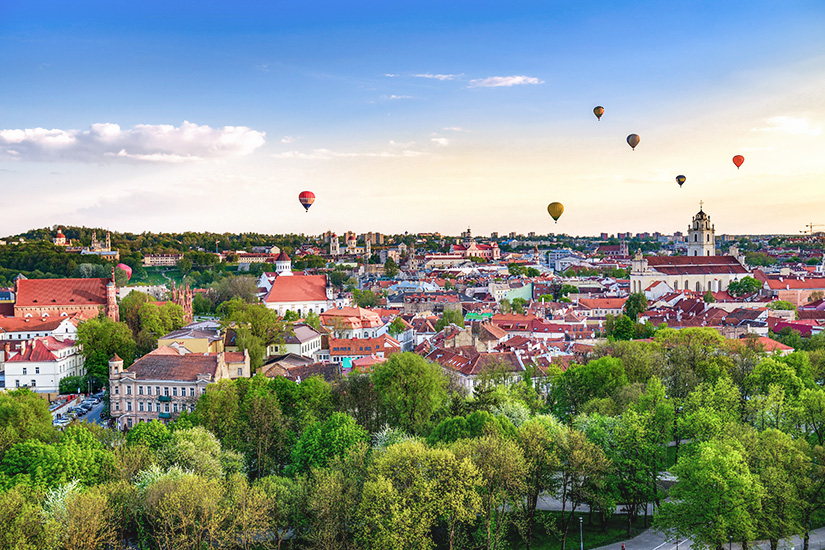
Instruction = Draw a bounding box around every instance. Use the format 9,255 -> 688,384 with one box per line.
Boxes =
372,353 -> 447,433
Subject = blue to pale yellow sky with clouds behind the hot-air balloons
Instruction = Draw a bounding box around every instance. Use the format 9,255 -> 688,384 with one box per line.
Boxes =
0,0 -> 825,239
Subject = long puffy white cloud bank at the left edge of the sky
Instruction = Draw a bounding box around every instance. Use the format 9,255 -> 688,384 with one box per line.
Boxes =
0,121 -> 266,163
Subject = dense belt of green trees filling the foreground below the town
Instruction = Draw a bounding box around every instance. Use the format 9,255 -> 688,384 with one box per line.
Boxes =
0,328 -> 825,550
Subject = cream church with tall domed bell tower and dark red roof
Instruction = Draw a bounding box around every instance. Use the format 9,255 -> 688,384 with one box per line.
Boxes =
630,203 -> 750,292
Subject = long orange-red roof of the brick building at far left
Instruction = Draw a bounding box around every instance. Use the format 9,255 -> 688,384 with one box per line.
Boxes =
15,279 -> 111,307
